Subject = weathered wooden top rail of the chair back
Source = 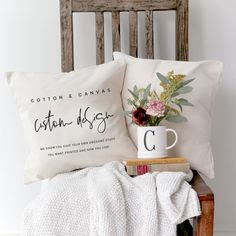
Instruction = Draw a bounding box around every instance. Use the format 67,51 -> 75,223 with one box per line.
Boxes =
72,0 -> 176,12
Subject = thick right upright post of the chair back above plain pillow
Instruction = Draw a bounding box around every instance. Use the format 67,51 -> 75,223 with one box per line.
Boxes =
176,0 -> 189,61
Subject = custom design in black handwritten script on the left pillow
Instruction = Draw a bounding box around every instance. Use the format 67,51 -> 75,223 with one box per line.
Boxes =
34,107 -> 114,133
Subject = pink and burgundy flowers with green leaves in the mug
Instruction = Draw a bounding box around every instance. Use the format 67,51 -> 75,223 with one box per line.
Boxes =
125,71 -> 194,126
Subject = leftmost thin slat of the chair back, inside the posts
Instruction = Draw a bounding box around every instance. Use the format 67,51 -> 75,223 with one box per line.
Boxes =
96,12 -> 104,65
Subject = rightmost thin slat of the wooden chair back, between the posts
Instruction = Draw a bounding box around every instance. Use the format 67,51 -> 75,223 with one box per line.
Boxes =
145,11 -> 154,59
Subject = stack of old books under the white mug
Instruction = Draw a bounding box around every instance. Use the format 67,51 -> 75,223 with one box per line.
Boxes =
123,157 -> 190,176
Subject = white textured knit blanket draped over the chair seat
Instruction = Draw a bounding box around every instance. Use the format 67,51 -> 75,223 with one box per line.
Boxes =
23,162 -> 200,236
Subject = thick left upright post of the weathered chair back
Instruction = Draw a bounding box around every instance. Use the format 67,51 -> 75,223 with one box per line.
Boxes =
60,0 -> 74,72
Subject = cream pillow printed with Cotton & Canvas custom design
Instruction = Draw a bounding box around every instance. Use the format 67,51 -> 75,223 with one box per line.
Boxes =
7,60 -> 136,183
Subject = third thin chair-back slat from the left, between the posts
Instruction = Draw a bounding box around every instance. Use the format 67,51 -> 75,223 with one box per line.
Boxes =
129,11 -> 138,57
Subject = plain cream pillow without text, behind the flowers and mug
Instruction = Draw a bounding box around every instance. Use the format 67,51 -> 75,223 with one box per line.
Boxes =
113,52 -> 222,178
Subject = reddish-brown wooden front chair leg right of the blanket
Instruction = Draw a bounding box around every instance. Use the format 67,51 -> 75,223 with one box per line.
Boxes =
193,199 -> 214,236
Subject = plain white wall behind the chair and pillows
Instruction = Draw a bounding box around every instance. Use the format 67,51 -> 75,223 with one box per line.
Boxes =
0,0 -> 236,236
